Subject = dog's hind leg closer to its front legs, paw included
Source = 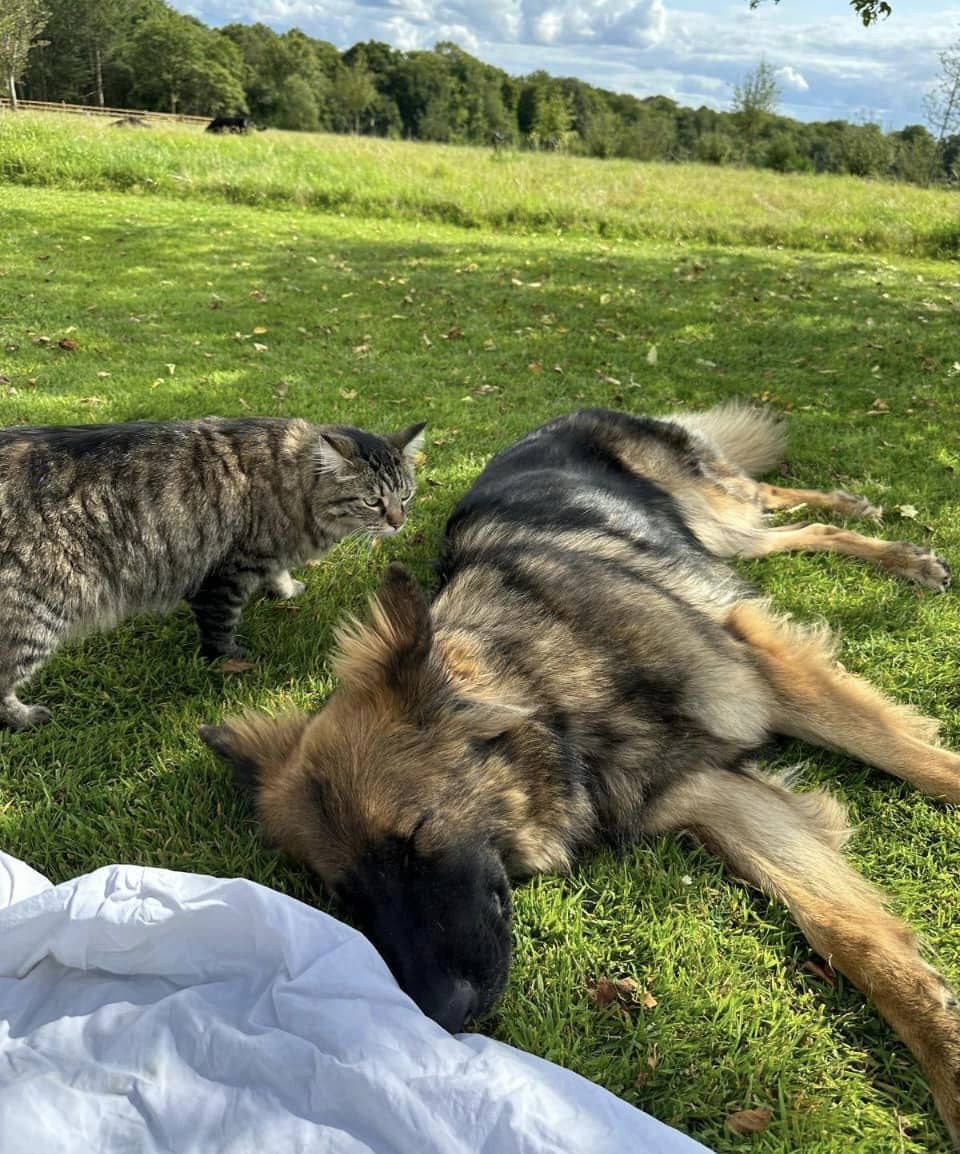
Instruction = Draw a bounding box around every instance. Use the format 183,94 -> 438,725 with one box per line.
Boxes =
737,523 -> 950,593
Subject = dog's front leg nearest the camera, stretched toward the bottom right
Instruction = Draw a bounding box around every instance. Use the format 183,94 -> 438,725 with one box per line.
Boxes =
648,770 -> 960,1148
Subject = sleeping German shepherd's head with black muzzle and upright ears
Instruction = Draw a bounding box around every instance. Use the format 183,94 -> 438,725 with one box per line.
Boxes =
201,565 -> 528,1032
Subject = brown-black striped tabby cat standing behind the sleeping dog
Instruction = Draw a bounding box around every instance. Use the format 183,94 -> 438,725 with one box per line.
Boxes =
0,418 -> 423,729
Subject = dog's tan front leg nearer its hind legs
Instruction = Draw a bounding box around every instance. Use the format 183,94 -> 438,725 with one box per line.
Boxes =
725,601 -> 960,802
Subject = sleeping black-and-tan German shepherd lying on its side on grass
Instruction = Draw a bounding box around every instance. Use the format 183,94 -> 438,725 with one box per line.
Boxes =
202,405 -> 960,1141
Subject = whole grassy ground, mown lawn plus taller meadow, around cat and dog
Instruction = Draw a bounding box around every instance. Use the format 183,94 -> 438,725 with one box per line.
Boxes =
0,110 -> 960,1154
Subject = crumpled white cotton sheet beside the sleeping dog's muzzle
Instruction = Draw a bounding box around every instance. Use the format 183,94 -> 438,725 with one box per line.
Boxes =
0,854 -> 704,1154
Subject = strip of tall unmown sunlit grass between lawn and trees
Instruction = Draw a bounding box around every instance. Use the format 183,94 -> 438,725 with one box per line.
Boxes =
0,114 -> 960,256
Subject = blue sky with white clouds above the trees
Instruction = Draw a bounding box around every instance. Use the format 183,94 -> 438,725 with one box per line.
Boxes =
173,0 -> 960,129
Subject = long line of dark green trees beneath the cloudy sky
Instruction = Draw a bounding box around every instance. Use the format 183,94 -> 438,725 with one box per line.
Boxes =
0,0 -> 960,183
